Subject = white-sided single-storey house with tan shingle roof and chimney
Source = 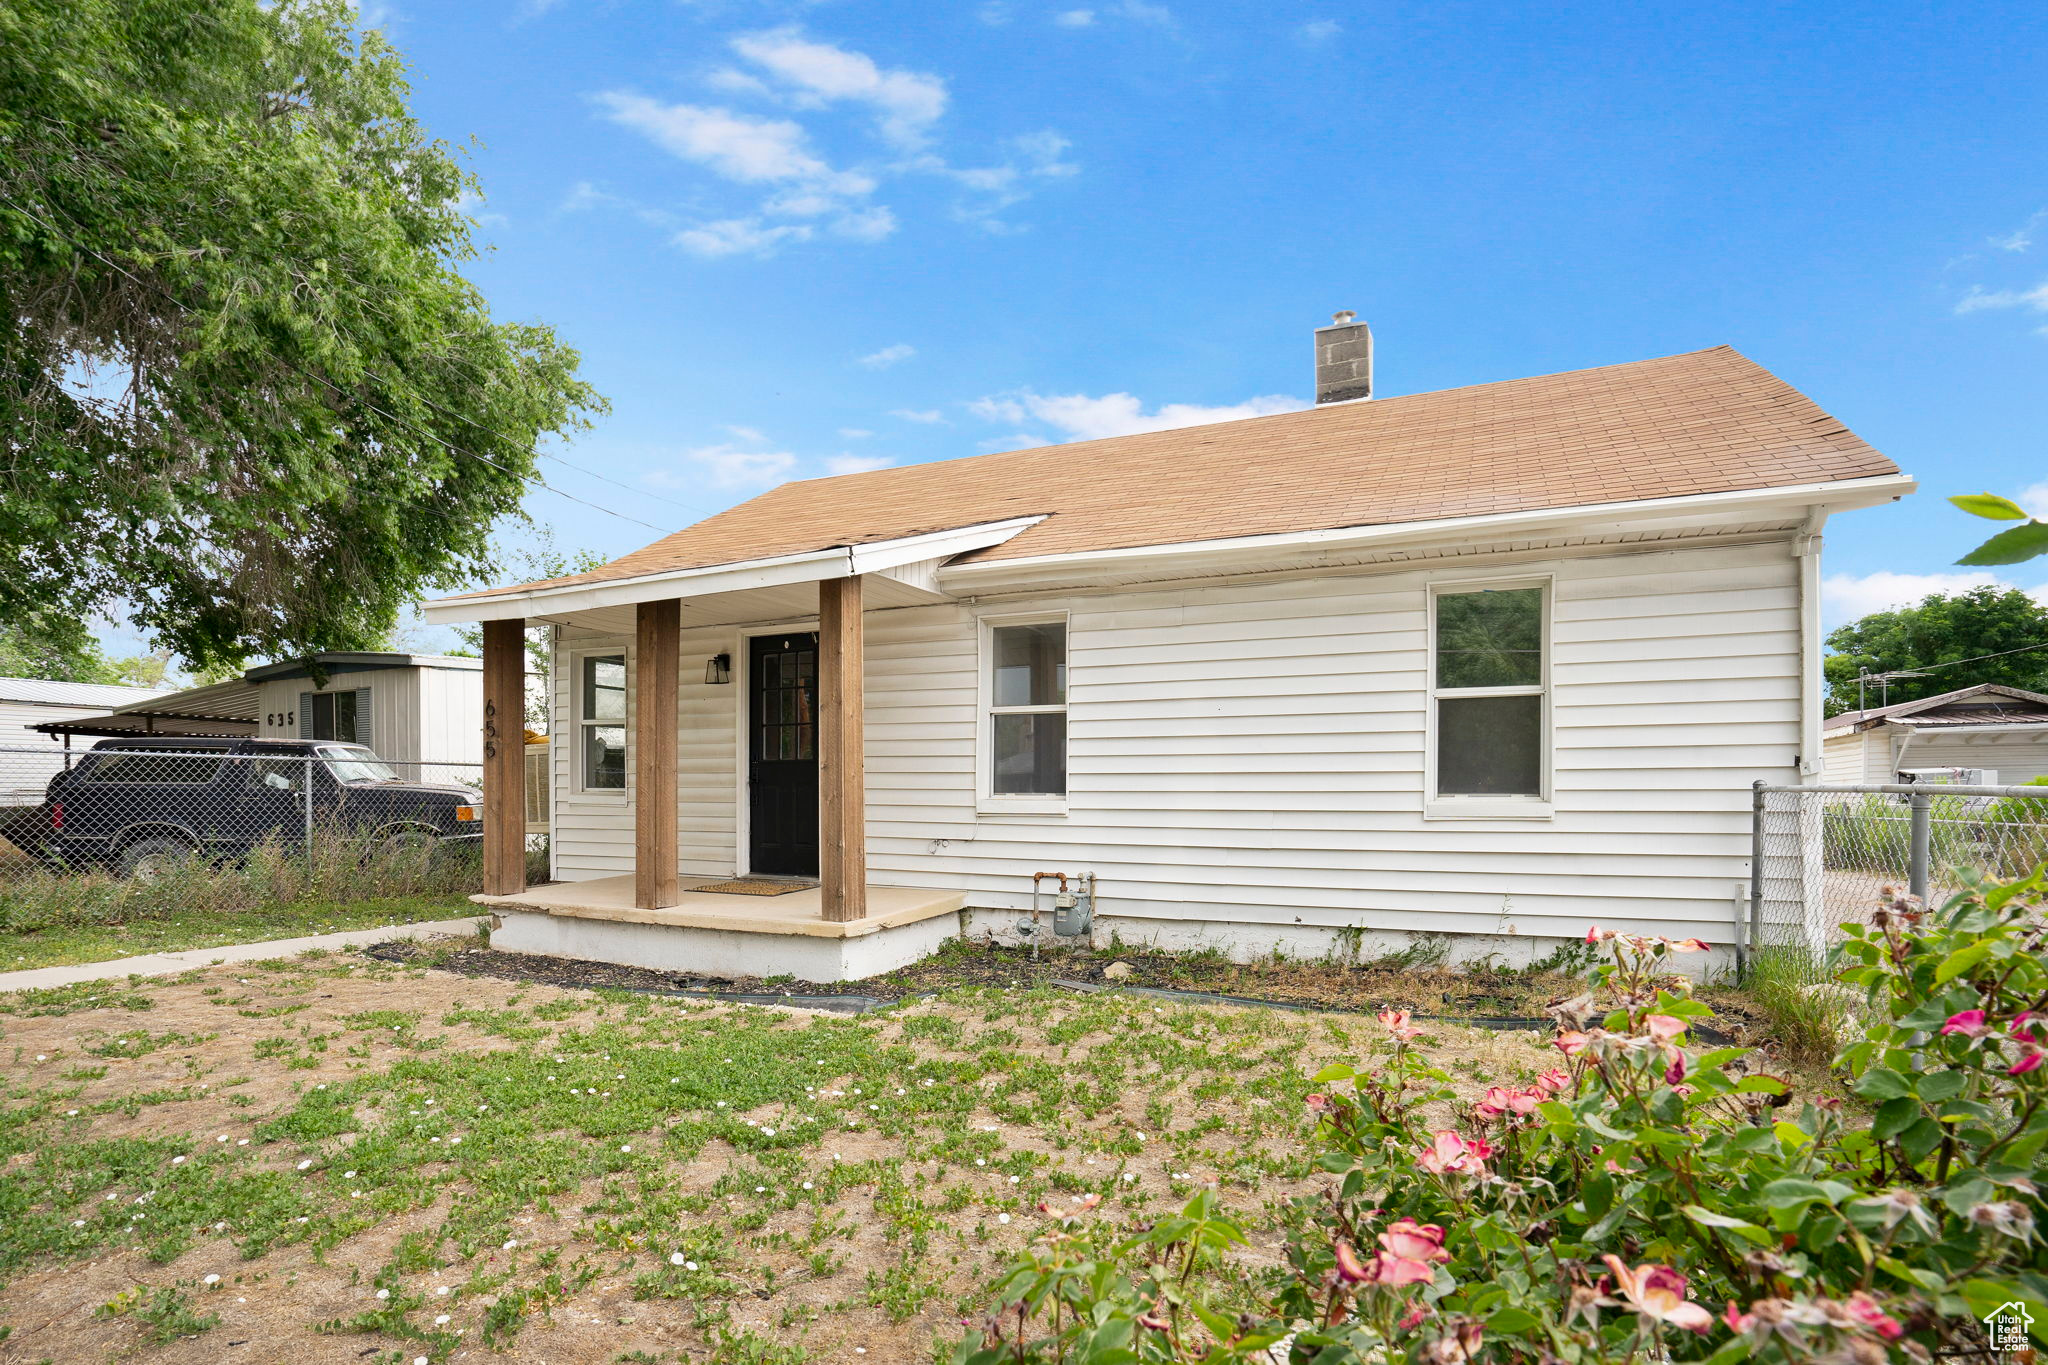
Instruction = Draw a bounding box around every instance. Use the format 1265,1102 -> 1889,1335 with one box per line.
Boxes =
428,315 -> 1913,980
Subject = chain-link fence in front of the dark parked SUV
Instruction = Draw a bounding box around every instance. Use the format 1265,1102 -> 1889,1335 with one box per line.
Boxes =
0,739 -> 483,882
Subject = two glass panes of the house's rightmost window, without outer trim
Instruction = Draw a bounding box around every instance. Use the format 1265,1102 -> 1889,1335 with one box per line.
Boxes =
1432,587 -> 1548,800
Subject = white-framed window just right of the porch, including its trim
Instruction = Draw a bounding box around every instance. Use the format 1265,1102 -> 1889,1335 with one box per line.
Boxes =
975,614 -> 1067,814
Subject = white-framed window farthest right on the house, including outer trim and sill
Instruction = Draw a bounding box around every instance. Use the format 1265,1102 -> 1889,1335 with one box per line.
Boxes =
1423,579 -> 1552,819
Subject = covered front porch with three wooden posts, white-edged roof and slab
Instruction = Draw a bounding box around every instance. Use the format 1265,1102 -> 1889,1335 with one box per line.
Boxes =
428,520 -> 1028,982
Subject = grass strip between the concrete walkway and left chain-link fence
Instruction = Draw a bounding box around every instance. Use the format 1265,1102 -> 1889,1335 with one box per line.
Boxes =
0,892 -> 477,972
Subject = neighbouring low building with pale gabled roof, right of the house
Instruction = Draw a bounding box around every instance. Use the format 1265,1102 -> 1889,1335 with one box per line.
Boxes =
1821,684 -> 2048,784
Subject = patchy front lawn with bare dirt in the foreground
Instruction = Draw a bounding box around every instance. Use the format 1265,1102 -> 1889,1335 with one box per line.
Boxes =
0,958 -> 1550,1365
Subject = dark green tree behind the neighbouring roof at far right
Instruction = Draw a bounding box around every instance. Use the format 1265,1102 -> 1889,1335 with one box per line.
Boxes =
1823,587 -> 2048,716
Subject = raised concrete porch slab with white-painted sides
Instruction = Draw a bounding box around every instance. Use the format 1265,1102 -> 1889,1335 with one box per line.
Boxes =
471,874 -> 967,982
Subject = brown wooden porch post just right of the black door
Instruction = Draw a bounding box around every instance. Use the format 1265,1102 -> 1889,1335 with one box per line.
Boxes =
817,575 -> 868,923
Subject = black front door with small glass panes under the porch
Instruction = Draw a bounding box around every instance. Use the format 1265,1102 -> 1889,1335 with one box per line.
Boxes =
748,632 -> 817,876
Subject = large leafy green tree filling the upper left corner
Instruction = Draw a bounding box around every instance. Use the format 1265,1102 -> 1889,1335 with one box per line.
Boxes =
0,0 -> 602,669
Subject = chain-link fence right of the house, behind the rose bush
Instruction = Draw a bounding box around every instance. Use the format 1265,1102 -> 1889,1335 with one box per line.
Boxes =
1749,784 -> 2048,960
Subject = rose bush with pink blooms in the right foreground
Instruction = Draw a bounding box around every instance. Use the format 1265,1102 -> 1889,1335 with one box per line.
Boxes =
954,872 -> 2048,1365
